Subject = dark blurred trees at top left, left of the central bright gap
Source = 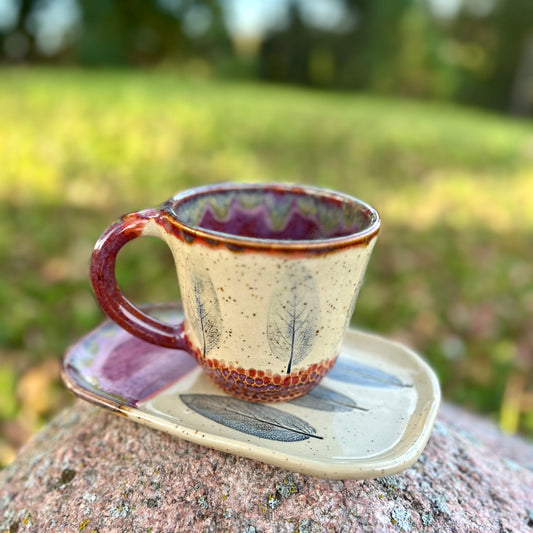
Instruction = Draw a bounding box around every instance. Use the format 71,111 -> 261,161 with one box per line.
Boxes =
0,0 -> 232,66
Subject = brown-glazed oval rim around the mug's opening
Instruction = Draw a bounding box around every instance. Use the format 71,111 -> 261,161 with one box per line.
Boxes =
161,182 -> 381,252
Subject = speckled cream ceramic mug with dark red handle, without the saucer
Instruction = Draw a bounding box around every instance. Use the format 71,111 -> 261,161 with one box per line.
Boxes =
91,183 -> 380,402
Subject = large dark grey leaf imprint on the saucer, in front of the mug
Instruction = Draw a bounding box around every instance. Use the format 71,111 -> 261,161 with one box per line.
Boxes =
180,394 -> 323,442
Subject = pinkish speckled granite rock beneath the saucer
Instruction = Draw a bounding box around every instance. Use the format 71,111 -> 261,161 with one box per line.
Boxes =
0,401 -> 533,533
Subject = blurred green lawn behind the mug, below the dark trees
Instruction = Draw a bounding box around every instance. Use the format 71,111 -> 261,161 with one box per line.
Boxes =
0,65 -> 533,458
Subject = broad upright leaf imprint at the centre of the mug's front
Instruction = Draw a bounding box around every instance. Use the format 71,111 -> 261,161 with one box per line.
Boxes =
267,266 -> 320,374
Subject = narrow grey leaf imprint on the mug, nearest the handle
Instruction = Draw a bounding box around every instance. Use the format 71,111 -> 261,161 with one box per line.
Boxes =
187,269 -> 222,357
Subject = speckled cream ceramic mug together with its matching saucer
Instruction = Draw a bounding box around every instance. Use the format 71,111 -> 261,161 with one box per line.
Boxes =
62,183 -> 440,479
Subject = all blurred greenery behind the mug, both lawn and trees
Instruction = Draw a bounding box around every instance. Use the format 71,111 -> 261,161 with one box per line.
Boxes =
0,0 -> 533,465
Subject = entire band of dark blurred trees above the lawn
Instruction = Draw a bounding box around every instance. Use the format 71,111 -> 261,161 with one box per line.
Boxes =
0,0 -> 533,113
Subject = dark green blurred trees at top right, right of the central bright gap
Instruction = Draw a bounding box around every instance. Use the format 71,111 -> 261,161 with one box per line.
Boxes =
258,0 -> 533,112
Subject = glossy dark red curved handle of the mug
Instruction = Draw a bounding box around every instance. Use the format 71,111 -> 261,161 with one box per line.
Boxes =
90,209 -> 190,351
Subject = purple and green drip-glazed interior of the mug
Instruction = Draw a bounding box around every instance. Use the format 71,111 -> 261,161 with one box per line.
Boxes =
171,185 -> 378,241
